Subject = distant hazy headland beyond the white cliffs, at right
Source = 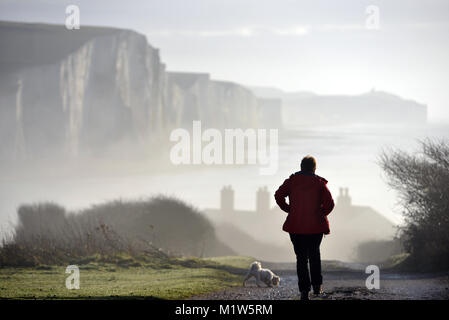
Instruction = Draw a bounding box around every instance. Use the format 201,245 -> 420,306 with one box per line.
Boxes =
250,87 -> 427,125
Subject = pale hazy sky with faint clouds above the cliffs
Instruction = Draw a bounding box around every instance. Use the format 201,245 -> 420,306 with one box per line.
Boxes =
0,0 -> 449,123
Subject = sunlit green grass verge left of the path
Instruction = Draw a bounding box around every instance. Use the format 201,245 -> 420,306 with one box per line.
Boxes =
0,256 -> 254,299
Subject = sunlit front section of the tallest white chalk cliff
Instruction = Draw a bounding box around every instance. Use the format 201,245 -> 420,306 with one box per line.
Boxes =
60,31 -> 167,156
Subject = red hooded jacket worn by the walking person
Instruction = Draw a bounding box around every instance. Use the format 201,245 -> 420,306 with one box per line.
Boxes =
274,171 -> 334,234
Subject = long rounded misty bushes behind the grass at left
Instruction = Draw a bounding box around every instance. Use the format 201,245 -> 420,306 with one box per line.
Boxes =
0,196 -> 233,266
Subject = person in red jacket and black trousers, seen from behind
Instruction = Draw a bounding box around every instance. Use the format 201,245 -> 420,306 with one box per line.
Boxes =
274,156 -> 334,300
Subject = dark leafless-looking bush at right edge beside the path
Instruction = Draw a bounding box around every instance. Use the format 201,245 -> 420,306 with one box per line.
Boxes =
380,140 -> 449,270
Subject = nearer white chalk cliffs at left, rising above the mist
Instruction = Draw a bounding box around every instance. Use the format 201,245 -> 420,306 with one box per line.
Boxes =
0,26 -> 266,158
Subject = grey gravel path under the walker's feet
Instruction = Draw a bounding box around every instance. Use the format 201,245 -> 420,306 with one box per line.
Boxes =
191,269 -> 449,300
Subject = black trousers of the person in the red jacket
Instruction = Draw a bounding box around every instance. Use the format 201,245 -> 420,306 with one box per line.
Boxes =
290,233 -> 323,291
